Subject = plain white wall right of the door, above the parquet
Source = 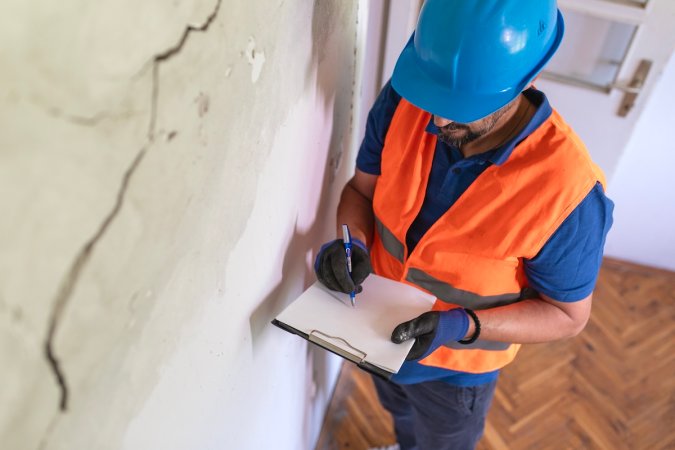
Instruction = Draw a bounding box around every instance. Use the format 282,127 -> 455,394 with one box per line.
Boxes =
605,54 -> 675,270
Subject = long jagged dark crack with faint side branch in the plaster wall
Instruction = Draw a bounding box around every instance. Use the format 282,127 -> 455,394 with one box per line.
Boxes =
42,0 -> 222,416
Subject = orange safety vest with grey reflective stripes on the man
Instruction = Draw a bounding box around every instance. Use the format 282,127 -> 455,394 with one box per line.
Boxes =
371,99 -> 605,373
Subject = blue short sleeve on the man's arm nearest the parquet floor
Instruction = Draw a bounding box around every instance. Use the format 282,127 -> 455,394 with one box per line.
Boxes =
524,183 -> 614,302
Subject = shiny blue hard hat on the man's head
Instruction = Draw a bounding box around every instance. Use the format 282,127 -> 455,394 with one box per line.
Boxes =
392,0 -> 564,123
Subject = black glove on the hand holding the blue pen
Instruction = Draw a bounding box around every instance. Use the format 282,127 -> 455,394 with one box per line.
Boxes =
314,239 -> 373,294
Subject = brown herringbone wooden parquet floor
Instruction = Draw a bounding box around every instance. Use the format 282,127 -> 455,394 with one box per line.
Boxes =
317,259 -> 675,450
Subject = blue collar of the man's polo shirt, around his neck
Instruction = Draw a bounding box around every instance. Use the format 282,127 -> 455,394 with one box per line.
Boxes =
425,87 -> 553,166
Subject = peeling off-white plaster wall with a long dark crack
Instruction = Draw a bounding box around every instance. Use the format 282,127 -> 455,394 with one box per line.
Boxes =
0,0 -> 358,449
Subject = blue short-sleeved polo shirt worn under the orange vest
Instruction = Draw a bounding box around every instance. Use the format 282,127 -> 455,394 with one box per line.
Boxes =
356,83 -> 614,386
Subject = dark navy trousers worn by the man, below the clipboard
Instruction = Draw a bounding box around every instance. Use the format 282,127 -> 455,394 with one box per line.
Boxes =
373,376 -> 497,450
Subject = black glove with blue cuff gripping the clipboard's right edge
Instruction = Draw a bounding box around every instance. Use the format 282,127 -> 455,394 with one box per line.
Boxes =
391,308 -> 469,361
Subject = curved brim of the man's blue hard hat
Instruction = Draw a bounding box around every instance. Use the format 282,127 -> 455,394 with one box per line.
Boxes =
391,11 -> 565,123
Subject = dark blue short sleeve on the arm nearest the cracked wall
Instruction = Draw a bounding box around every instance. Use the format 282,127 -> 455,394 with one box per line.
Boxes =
356,81 -> 401,175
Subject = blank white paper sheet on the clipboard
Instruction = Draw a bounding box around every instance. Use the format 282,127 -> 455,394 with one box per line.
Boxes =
277,275 -> 434,373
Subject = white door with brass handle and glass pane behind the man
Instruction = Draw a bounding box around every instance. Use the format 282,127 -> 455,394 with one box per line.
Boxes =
537,0 -> 675,180
